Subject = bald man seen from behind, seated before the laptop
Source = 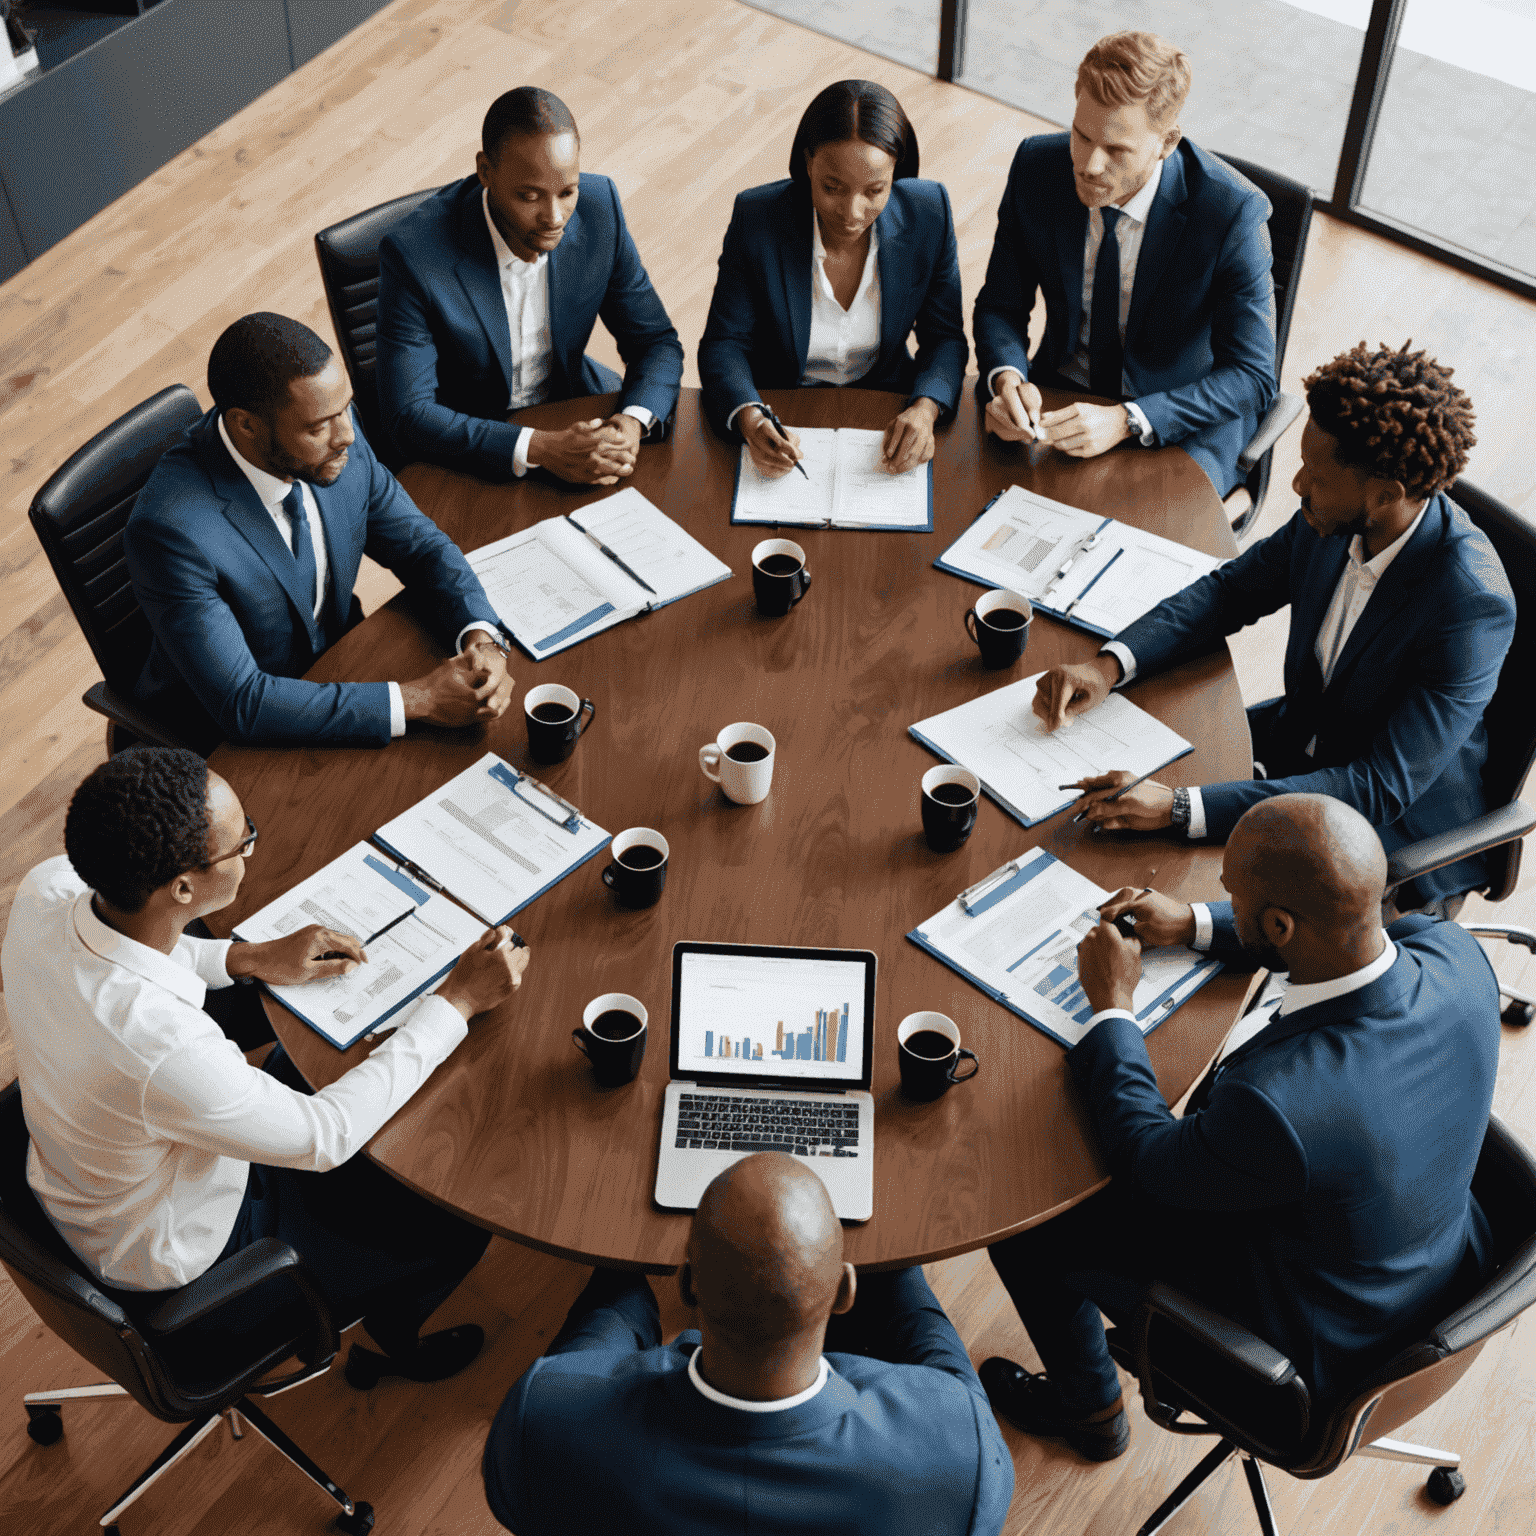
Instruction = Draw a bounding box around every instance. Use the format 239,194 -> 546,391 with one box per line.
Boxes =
484,1152 -> 1014,1536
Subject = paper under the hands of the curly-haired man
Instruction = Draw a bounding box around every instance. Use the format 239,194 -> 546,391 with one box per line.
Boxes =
909,673 -> 1193,826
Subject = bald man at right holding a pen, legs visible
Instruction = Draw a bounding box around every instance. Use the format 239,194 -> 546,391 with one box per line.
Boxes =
982,794 -> 1499,1461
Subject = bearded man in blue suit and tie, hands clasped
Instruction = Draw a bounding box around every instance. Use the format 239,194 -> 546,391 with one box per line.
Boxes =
123,313 -> 511,751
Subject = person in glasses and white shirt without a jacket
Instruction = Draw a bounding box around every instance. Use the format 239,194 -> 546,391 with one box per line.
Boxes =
0,746 -> 528,1385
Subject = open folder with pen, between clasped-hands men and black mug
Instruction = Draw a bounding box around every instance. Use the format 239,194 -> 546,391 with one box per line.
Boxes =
467,485 -> 731,660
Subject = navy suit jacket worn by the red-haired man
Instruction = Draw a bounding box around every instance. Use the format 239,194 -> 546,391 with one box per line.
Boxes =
972,134 -> 1276,496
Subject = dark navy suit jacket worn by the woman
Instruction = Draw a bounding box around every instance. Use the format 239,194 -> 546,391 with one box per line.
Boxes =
699,177 -> 969,445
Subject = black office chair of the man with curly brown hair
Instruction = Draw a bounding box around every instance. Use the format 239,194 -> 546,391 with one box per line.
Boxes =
1387,479 -> 1536,1025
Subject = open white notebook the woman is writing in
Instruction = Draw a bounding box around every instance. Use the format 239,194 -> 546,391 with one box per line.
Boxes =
731,427 -> 934,533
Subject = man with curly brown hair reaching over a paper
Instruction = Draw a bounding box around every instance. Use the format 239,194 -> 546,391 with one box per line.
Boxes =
1034,343 -> 1514,911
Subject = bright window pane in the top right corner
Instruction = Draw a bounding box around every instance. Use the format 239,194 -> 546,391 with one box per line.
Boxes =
1358,0 -> 1536,278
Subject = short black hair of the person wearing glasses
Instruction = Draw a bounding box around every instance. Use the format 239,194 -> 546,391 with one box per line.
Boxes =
65,746 -> 209,912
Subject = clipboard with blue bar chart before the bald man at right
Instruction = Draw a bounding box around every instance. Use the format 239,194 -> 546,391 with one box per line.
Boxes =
906,849 -> 1221,1046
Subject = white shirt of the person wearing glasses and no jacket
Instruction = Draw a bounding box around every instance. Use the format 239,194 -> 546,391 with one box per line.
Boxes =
0,856 -> 467,1290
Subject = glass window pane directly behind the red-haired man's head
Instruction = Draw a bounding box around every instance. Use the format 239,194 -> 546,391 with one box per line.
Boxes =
957,0 -> 1363,194
